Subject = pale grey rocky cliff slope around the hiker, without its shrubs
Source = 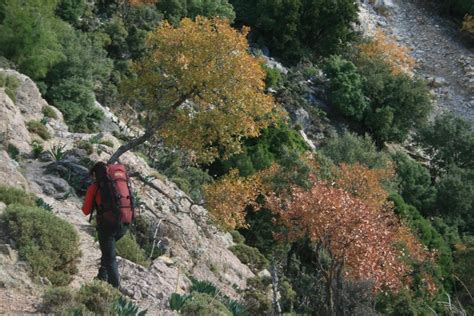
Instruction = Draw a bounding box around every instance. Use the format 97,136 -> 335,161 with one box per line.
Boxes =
0,69 -> 253,315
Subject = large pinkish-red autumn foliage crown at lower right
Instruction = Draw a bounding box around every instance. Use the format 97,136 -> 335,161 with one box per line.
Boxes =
267,181 -> 426,291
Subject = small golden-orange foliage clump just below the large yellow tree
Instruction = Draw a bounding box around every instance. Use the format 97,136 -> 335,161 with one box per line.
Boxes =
204,169 -> 264,230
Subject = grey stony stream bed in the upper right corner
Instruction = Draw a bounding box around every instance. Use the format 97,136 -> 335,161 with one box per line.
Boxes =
377,0 -> 474,121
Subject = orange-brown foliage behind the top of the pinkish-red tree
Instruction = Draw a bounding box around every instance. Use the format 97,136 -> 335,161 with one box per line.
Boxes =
334,163 -> 395,209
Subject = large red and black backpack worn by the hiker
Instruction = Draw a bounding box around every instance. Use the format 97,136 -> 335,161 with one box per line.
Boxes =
97,164 -> 135,226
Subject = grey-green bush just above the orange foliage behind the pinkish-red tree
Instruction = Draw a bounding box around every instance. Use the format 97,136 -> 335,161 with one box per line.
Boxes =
321,132 -> 389,168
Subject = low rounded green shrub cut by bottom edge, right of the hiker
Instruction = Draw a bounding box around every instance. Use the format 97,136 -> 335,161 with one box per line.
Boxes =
181,293 -> 232,316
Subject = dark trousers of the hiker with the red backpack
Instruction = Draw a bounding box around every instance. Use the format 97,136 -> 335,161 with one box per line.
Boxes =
97,224 -> 128,288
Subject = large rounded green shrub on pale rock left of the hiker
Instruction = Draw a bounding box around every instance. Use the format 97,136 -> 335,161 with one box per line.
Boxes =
4,204 -> 80,285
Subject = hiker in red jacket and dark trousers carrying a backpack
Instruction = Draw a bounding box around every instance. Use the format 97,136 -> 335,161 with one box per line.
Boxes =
82,162 -> 134,288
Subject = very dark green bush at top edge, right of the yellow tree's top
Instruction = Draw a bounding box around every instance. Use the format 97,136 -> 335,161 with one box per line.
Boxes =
230,0 -> 357,63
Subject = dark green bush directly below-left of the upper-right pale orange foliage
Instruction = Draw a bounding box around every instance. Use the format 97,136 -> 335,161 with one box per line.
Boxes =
324,55 -> 367,120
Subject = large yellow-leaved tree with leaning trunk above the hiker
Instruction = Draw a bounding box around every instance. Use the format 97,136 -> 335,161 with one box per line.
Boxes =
109,17 -> 276,162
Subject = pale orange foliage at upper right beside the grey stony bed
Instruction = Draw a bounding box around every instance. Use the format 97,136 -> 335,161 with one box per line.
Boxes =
359,29 -> 416,74
